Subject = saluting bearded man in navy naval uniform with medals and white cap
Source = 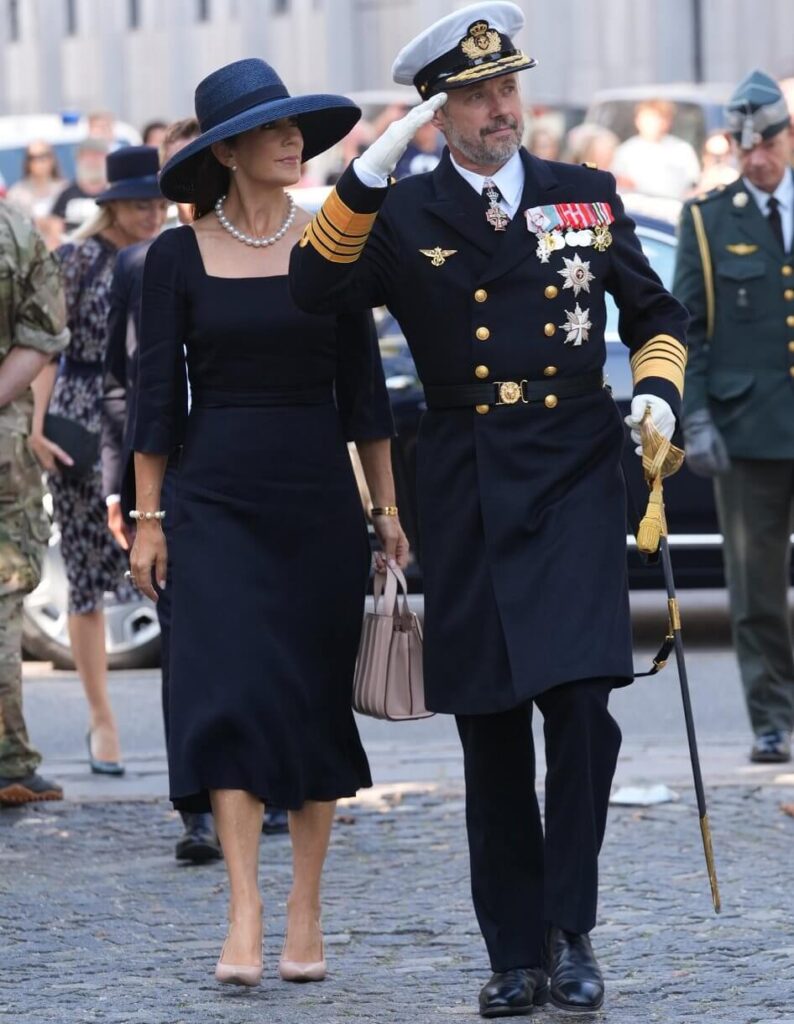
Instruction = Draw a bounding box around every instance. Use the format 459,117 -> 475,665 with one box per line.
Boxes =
290,3 -> 686,1017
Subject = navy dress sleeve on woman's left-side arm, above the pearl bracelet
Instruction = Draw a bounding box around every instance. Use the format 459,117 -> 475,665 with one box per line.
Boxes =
132,234 -> 187,455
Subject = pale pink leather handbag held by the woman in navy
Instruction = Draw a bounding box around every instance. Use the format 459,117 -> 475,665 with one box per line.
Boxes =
352,568 -> 433,722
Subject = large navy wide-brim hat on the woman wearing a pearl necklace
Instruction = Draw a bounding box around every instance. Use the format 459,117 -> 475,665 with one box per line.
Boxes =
160,57 -> 362,203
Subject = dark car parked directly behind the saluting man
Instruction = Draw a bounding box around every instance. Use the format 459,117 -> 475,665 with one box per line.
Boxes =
378,197 -> 724,589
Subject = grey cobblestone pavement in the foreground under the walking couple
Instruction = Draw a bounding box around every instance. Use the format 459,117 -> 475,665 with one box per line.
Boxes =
0,785 -> 794,1024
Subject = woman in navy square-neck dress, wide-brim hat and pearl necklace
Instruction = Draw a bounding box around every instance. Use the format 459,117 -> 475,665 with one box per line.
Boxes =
130,59 -> 407,985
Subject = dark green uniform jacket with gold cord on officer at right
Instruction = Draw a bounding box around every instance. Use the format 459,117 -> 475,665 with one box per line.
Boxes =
673,172 -> 794,459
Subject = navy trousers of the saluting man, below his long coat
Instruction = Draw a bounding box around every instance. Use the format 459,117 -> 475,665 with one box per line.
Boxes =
456,679 -> 621,972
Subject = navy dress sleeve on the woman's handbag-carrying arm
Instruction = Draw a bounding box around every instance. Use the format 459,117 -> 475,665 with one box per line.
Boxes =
335,310 -> 394,441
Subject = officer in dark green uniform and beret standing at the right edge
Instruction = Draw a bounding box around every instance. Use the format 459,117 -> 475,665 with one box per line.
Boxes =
673,71 -> 794,762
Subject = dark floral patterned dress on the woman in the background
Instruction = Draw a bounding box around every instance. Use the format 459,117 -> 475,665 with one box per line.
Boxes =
49,236 -> 134,614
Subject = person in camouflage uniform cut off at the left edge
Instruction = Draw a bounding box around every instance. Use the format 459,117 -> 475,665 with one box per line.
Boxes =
0,202 -> 69,805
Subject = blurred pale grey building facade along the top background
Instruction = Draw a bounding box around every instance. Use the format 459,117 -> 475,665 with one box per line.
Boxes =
0,0 -> 794,126
